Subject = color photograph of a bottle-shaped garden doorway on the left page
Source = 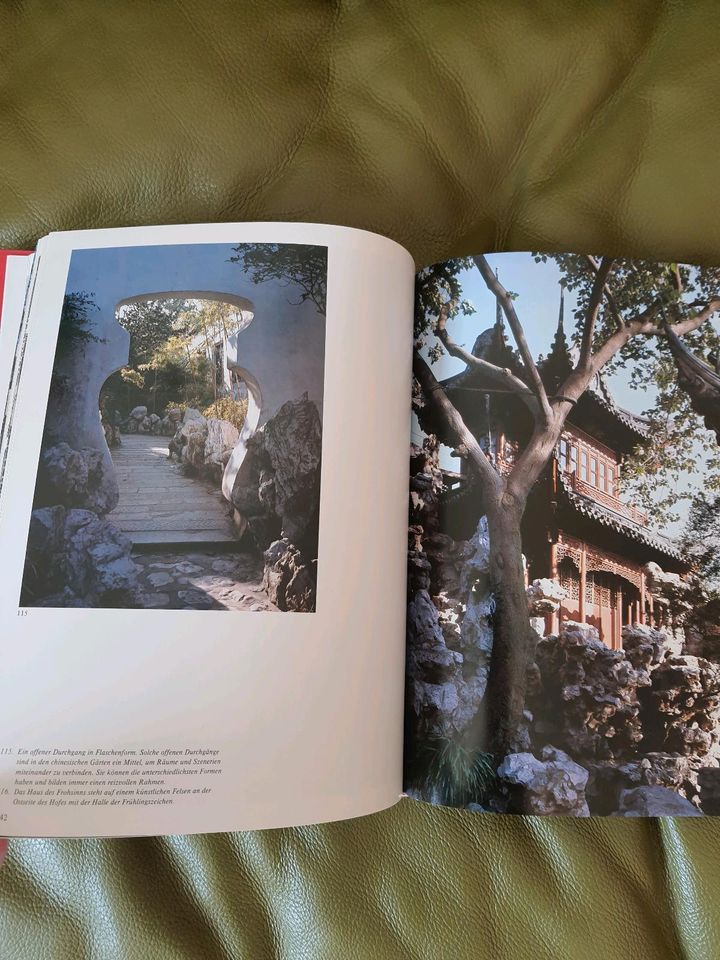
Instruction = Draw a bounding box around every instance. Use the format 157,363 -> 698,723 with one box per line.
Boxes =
20,243 -> 327,613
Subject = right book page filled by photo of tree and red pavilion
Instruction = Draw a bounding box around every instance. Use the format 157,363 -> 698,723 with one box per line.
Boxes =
405,253 -> 720,816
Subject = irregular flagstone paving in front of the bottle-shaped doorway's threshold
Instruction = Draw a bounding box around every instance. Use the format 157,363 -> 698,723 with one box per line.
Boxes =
133,552 -> 278,611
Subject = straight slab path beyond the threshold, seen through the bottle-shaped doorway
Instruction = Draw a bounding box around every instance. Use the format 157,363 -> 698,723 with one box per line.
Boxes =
108,433 -> 237,544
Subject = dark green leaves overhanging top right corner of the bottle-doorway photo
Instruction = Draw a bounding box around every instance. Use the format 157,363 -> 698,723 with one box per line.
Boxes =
230,243 -> 327,316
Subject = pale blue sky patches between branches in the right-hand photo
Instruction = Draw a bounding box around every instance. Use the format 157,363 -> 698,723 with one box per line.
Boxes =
412,253 -> 716,536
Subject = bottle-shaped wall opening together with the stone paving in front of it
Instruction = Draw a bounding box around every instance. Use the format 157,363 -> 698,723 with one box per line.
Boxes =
94,290 -> 272,609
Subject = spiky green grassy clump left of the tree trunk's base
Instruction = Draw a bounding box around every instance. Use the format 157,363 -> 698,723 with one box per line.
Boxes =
409,737 -> 496,807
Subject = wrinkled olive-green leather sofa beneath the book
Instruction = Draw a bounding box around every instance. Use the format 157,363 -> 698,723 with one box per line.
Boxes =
0,0 -> 720,960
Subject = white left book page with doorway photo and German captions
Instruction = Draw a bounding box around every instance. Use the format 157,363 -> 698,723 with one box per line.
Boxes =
0,223 -> 414,837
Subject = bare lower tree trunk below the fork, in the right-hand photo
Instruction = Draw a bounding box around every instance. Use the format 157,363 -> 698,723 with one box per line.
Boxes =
487,491 -> 536,762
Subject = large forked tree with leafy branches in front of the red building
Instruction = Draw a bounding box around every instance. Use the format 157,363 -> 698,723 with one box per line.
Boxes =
413,255 -> 720,759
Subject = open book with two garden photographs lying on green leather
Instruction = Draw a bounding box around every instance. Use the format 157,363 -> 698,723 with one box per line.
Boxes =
0,223 -> 720,836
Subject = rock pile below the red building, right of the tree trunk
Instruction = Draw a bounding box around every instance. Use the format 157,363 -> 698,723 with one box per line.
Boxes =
506,623 -> 720,816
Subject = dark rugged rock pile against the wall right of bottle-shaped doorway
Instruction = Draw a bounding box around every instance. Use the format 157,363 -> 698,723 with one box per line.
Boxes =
229,394 -> 322,612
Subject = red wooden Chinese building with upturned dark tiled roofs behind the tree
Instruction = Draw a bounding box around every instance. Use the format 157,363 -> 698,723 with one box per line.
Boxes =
434,294 -> 687,648
